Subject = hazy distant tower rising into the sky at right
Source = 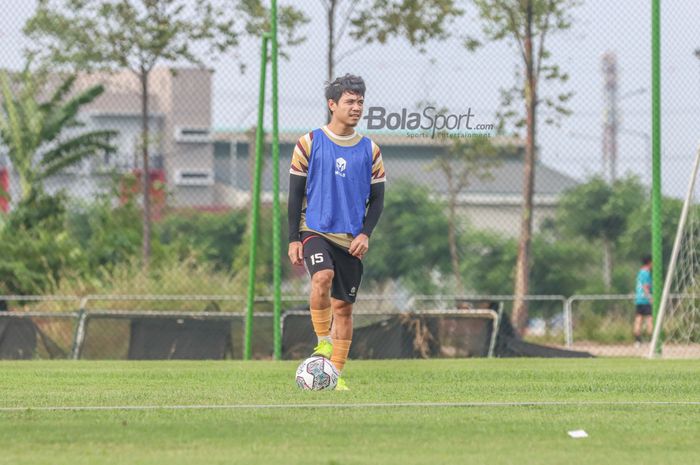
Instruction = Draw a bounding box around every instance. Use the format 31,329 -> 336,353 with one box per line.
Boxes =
602,52 -> 618,183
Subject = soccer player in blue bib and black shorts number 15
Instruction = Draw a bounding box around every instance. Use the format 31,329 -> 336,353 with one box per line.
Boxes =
288,74 -> 386,390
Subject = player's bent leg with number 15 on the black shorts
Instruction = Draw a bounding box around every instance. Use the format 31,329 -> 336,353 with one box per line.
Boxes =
302,235 -> 335,359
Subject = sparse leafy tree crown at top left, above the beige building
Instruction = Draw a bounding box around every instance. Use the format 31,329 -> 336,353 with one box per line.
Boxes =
24,0 -> 232,72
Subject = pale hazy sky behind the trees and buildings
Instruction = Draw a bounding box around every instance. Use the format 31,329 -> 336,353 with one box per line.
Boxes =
0,0 -> 700,196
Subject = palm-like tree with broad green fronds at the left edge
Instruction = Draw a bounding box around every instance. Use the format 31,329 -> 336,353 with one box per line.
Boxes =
0,65 -> 116,203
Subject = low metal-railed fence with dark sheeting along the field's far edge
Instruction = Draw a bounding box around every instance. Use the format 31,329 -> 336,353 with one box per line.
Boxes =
0,295 -> 680,360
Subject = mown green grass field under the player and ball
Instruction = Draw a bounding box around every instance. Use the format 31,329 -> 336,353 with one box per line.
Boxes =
0,359 -> 700,465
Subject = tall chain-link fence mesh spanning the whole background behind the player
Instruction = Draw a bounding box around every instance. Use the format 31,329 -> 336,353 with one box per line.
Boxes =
0,0 -> 700,358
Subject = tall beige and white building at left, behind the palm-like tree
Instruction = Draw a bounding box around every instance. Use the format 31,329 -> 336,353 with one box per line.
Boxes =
1,68 -> 217,207
